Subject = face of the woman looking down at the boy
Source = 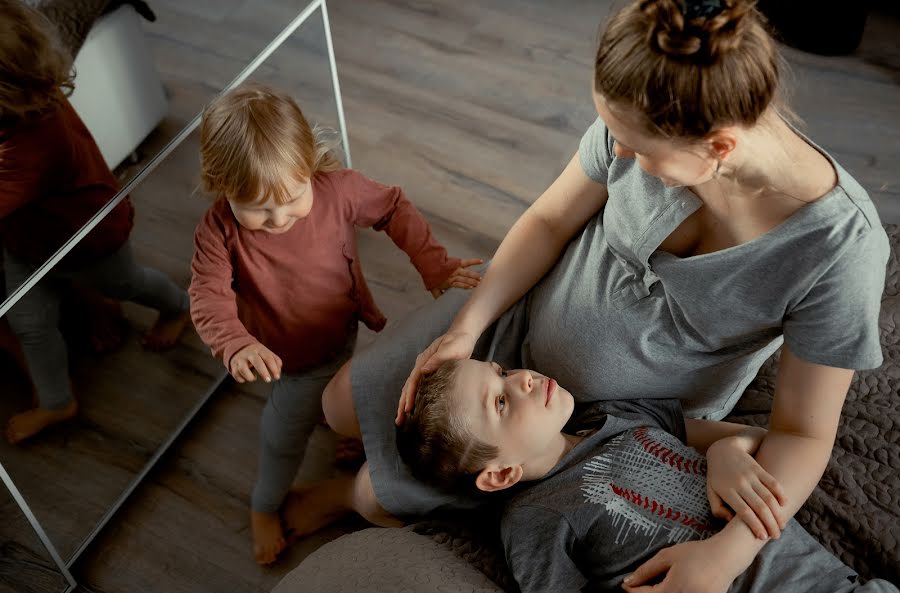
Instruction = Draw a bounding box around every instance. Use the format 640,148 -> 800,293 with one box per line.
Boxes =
594,92 -> 718,187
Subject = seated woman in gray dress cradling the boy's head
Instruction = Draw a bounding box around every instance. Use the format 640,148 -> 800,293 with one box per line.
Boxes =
285,0 -> 888,591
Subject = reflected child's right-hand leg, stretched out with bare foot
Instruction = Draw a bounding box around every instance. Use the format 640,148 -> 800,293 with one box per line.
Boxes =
76,243 -> 191,350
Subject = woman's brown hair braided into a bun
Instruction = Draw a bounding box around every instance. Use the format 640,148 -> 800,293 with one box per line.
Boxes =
594,0 -> 781,140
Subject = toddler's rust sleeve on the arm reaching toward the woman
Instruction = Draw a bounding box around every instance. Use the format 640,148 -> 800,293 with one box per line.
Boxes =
340,170 -> 460,290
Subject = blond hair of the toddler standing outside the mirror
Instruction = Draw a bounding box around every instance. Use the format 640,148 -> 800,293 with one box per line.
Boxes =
200,83 -> 341,204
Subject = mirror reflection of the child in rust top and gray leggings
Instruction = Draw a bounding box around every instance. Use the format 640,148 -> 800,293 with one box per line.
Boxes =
0,0 -> 190,443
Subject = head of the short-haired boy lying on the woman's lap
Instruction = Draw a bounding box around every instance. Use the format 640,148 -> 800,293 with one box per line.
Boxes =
397,360 -> 575,492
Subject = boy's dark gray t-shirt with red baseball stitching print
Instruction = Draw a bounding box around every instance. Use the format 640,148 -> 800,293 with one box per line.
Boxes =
501,400 -> 872,593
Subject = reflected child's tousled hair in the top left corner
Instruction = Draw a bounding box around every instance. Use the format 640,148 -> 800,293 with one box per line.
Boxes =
0,0 -> 74,123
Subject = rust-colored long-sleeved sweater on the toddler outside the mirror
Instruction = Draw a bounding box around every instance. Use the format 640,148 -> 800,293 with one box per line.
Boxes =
189,169 -> 459,373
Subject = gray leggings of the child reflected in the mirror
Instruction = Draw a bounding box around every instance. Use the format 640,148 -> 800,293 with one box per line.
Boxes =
3,243 -> 189,410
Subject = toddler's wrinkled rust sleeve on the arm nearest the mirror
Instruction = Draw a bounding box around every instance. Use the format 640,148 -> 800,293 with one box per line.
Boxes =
188,208 -> 257,368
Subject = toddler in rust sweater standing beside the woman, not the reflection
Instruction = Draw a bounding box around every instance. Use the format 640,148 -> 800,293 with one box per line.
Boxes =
190,84 -> 481,564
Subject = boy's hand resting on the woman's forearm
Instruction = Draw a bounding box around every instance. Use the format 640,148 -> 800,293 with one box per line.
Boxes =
706,436 -> 787,539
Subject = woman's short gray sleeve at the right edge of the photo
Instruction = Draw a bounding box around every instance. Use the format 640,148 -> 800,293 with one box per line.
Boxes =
784,228 -> 890,370
